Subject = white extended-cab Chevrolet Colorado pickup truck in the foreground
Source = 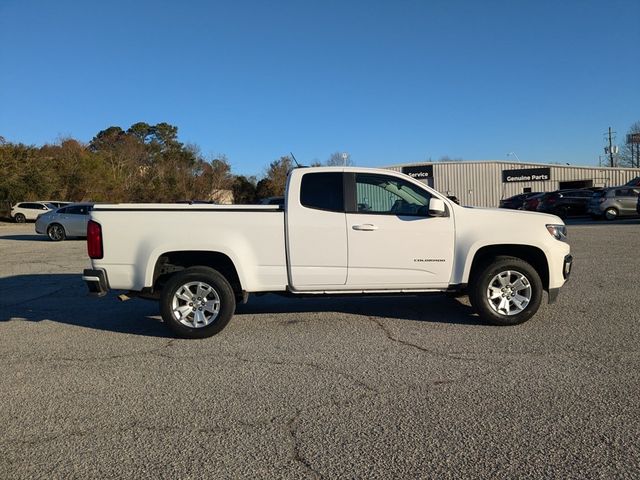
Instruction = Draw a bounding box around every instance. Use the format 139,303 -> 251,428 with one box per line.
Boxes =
83,167 -> 572,338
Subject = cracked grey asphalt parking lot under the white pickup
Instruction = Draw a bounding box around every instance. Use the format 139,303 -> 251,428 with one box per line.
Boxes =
0,219 -> 640,479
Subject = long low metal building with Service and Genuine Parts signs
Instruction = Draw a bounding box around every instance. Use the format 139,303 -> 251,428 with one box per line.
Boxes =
387,161 -> 640,207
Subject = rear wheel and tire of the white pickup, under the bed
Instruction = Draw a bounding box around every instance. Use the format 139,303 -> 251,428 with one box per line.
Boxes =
160,267 -> 236,338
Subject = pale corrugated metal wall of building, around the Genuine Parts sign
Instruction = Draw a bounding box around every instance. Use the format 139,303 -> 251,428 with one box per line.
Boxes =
388,161 -> 640,207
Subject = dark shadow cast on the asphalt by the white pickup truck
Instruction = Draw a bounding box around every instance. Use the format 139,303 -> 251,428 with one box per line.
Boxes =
0,274 -> 482,338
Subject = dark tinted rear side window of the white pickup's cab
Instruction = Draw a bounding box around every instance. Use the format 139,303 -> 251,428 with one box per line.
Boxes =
300,172 -> 344,212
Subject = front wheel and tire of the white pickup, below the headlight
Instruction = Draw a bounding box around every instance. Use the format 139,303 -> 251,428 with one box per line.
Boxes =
469,257 -> 543,326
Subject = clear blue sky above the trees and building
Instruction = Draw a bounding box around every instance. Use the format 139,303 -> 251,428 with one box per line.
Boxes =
0,0 -> 640,174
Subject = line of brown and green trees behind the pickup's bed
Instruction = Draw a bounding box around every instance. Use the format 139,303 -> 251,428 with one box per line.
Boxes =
0,122 -> 350,203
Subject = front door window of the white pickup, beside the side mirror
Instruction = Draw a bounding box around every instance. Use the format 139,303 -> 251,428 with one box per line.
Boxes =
356,173 -> 431,216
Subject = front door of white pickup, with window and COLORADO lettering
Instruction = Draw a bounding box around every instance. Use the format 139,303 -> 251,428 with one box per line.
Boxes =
346,173 -> 454,288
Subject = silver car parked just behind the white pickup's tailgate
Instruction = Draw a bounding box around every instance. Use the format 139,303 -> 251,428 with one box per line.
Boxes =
36,203 -> 93,242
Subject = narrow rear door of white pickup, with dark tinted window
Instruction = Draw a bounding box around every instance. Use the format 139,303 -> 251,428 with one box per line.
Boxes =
286,170 -> 347,290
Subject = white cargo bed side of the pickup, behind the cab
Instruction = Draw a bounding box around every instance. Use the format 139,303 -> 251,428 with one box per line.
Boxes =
91,203 -> 287,291
